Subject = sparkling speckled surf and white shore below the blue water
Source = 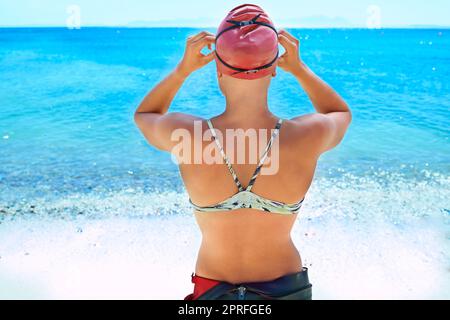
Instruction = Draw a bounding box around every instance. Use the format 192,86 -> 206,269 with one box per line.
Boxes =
0,173 -> 450,299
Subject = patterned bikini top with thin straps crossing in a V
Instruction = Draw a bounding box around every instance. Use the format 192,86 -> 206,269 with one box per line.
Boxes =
189,119 -> 305,215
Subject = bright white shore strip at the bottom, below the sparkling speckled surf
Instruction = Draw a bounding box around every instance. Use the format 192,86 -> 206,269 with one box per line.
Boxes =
0,212 -> 450,299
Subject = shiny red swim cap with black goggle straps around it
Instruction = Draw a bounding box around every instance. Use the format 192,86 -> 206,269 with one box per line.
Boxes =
216,4 -> 279,80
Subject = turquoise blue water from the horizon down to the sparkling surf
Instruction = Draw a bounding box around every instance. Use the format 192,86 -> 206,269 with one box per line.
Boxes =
0,29 -> 450,201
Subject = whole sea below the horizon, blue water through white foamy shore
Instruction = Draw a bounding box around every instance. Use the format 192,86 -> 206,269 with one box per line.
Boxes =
0,28 -> 450,299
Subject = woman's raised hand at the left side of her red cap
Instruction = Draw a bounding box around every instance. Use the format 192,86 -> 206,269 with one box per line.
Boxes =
177,31 -> 216,77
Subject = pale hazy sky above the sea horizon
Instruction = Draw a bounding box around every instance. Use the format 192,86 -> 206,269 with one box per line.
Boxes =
0,0 -> 450,27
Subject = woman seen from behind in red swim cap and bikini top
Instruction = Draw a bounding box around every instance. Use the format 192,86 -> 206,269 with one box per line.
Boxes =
135,5 -> 352,300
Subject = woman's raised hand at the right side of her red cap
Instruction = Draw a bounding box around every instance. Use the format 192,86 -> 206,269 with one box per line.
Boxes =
278,30 -> 303,73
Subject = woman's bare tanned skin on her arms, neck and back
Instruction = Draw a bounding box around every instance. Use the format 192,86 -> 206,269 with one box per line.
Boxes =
135,30 -> 352,283
